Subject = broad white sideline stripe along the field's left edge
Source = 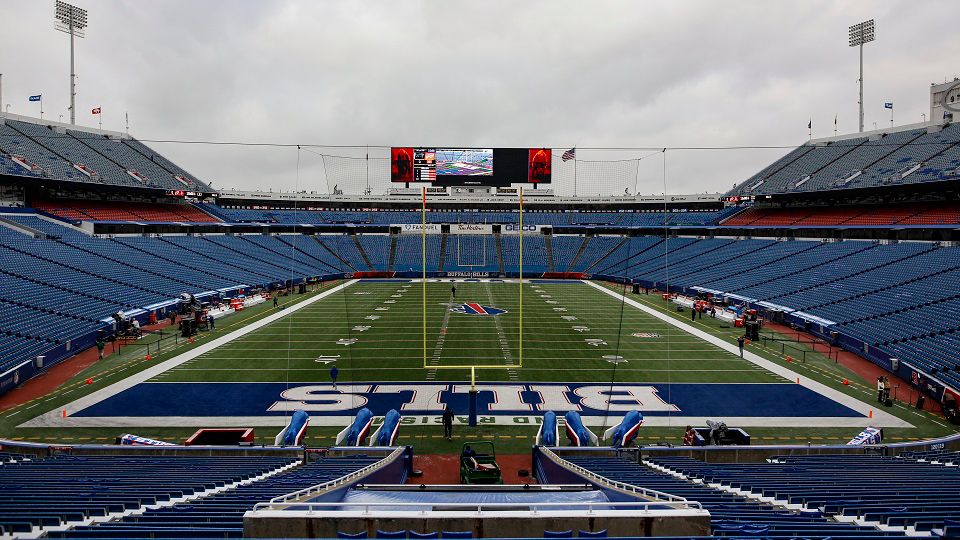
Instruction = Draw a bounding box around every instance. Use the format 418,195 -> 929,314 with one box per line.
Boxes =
18,279 -> 359,427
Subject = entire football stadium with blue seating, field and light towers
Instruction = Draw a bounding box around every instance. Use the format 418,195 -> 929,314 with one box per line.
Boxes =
0,2 -> 960,539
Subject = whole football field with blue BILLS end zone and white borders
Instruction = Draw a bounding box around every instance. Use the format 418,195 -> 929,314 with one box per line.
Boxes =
21,280 -> 912,429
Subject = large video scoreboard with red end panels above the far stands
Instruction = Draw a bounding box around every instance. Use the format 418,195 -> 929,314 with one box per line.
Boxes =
390,147 -> 552,186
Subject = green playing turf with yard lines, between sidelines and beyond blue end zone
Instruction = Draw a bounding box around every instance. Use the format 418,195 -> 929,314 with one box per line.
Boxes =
154,282 -> 783,382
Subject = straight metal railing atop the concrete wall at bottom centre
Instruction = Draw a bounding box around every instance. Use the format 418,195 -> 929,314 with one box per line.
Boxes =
252,500 -> 704,516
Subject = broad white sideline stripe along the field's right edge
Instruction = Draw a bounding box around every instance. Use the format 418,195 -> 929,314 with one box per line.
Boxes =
582,280 -> 916,428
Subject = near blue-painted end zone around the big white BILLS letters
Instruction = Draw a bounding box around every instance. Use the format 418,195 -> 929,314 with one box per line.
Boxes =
71,382 -> 864,418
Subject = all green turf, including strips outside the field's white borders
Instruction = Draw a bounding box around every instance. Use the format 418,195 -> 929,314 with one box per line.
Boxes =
0,282 -> 954,452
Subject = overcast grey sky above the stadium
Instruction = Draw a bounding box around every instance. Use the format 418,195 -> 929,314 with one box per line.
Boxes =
0,0 -> 960,195
